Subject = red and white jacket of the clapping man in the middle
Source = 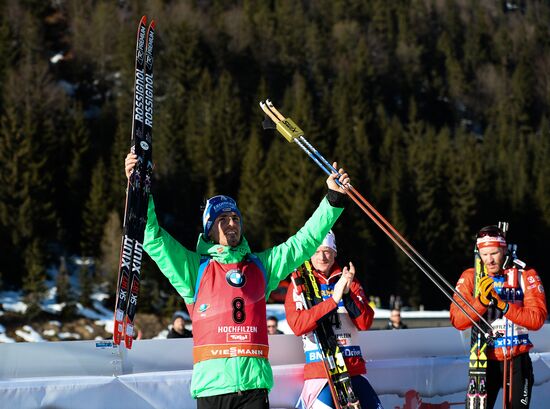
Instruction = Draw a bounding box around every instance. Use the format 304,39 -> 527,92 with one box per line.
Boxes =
285,263 -> 374,379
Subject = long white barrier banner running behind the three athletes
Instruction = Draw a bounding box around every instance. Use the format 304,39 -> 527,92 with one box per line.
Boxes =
0,324 -> 550,409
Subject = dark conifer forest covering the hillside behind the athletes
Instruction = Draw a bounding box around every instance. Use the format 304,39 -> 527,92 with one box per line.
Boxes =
0,0 -> 550,314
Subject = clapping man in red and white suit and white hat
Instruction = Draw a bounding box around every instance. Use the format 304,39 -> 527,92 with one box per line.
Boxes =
285,231 -> 382,409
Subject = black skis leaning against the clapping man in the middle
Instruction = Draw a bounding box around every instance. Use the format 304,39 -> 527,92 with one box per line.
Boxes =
291,261 -> 361,409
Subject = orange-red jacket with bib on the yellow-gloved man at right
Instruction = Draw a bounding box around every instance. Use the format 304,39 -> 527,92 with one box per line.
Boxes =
450,268 -> 547,361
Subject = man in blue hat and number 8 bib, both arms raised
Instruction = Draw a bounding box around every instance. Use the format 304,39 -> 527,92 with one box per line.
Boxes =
125,154 -> 349,409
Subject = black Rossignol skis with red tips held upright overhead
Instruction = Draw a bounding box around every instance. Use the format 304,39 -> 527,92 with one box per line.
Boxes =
113,16 -> 155,349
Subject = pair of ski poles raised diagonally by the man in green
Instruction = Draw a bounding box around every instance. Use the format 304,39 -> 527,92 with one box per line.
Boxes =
260,100 -> 494,339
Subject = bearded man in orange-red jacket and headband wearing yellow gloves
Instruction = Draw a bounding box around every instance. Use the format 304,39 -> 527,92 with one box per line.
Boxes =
451,226 -> 547,409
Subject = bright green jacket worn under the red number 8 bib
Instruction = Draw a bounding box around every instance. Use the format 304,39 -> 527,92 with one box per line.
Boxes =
144,197 -> 343,398
